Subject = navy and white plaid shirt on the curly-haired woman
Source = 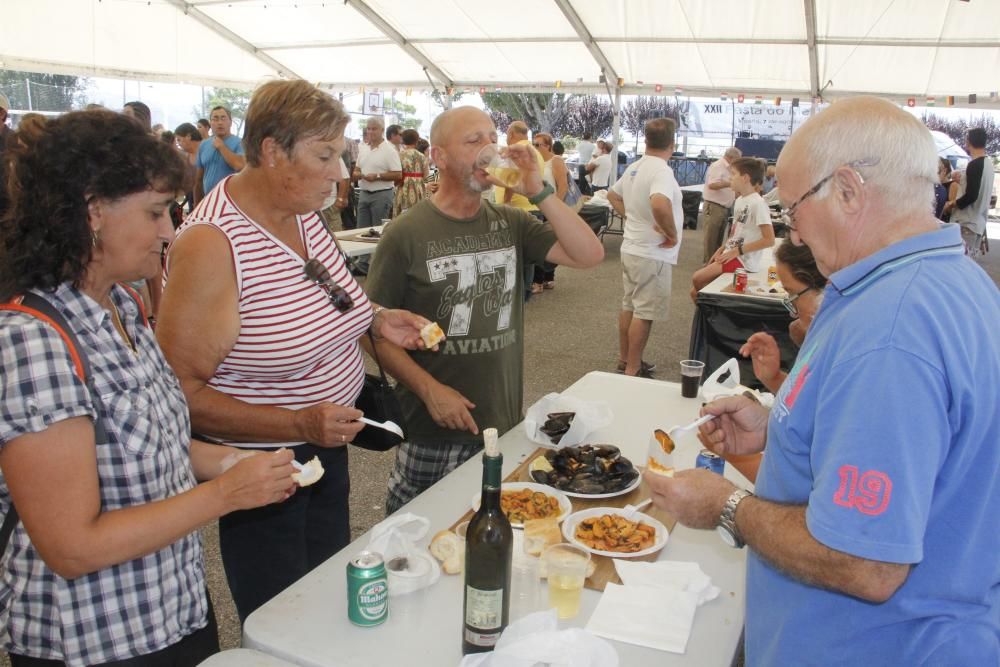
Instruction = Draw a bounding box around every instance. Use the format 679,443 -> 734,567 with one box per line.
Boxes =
0,285 -> 208,667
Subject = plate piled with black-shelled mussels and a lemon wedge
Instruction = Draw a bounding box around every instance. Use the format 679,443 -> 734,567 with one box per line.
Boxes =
528,445 -> 642,498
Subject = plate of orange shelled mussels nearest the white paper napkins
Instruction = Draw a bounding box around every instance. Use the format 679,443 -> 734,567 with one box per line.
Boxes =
563,507 -> 669,558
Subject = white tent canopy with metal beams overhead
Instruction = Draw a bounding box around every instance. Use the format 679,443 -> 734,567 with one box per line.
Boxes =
0,0 -> 1000,106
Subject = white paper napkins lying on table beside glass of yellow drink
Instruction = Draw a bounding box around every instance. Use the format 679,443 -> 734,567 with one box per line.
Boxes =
587,559 -> 719,653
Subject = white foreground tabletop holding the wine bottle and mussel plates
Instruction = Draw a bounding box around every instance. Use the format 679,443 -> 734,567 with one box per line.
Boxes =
243,372 -> 748,667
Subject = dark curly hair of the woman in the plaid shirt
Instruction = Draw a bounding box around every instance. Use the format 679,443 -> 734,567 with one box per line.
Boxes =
0,111 -> 188,301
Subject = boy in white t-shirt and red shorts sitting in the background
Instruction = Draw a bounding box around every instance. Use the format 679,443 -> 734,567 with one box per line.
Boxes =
691,157 -> 774,301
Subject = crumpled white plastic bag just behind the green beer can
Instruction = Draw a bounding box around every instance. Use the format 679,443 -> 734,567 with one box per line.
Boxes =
368,512 -> 441,597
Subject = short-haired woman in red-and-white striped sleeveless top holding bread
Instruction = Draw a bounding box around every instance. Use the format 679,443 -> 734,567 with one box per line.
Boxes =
157,81 -> 428,621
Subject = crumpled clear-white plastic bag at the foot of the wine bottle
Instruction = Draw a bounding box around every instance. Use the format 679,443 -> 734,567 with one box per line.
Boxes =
459,609 -> 618,667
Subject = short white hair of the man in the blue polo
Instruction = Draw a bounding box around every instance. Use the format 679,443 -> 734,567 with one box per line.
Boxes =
792,97 -> 938,213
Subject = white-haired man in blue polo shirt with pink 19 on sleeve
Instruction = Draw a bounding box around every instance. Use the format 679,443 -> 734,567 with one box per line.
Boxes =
647,97 -> 1000,665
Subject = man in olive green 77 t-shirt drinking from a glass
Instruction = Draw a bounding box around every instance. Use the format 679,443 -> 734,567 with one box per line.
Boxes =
365,107 -> 604,513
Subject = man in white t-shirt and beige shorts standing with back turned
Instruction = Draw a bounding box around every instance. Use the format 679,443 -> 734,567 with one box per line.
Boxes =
608,118 -> 684,377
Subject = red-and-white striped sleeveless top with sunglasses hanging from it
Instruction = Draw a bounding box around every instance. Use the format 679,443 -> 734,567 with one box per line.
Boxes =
165,178 -> 372,448
